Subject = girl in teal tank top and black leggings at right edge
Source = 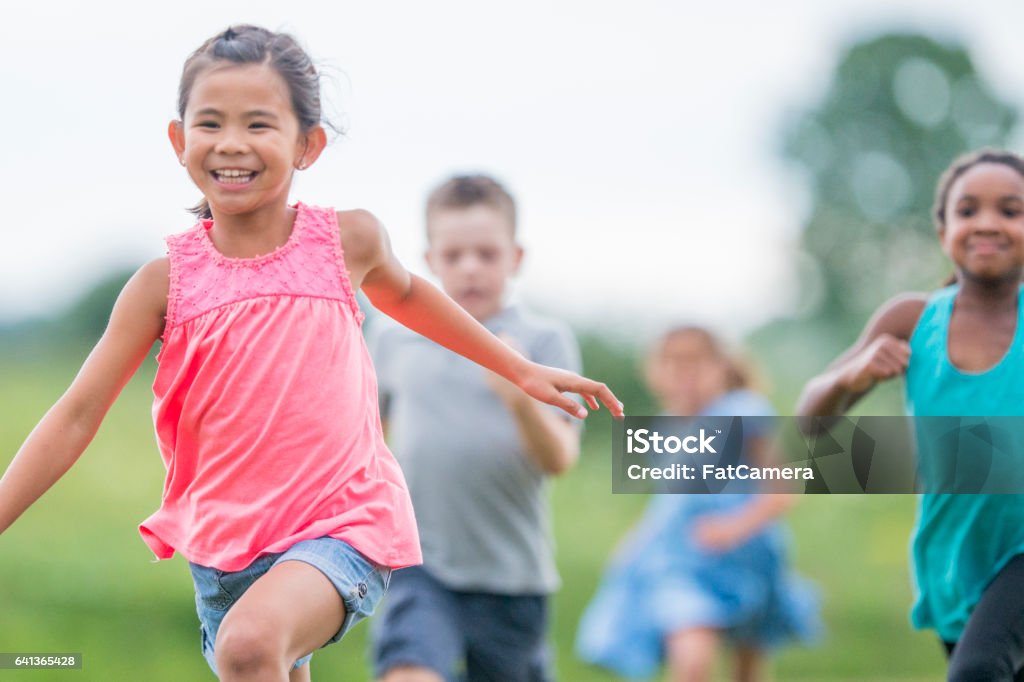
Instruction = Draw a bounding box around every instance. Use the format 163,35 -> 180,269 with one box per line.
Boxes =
798,151 -> 1024,682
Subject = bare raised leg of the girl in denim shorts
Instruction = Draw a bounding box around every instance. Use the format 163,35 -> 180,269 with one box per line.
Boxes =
214,561 -> 345,682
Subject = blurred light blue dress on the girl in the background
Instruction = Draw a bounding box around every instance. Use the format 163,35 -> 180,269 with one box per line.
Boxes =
577,391 -> 820,677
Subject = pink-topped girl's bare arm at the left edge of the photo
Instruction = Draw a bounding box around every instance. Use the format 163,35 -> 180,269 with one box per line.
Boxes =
0,258 -> 168,532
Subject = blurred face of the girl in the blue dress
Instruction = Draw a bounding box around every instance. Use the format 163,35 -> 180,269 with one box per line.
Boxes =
647,332 -> 729,416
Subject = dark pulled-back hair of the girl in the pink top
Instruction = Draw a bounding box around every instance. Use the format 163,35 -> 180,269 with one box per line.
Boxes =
178,25 -> 322,218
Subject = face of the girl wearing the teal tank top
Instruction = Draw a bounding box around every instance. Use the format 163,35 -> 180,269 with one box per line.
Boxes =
939,163 -> 1024,282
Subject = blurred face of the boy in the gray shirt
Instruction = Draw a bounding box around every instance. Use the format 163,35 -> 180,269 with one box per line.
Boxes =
426,204 -> 522,321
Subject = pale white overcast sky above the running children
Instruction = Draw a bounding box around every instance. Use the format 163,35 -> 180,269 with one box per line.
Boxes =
6,0 -> 1024,334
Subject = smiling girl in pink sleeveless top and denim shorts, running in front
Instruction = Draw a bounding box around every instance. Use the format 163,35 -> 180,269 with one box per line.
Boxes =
0,26 -> 622,680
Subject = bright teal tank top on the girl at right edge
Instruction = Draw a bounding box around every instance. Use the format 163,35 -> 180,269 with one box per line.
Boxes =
905,285 -> 1024,642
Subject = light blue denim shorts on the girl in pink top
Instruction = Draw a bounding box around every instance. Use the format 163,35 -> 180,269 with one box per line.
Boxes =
188,537 -> 391,675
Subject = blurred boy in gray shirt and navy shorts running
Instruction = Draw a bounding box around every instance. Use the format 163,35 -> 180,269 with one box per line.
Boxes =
371,175 -> 580,682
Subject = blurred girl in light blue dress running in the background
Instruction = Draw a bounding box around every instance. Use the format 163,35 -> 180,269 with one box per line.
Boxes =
577,327 -> 818,682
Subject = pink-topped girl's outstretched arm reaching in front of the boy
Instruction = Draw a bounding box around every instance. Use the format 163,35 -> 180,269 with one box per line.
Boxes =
348,212 -> 623,418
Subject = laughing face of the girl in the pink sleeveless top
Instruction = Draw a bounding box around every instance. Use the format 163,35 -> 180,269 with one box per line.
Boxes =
169,63 -> 323,215
